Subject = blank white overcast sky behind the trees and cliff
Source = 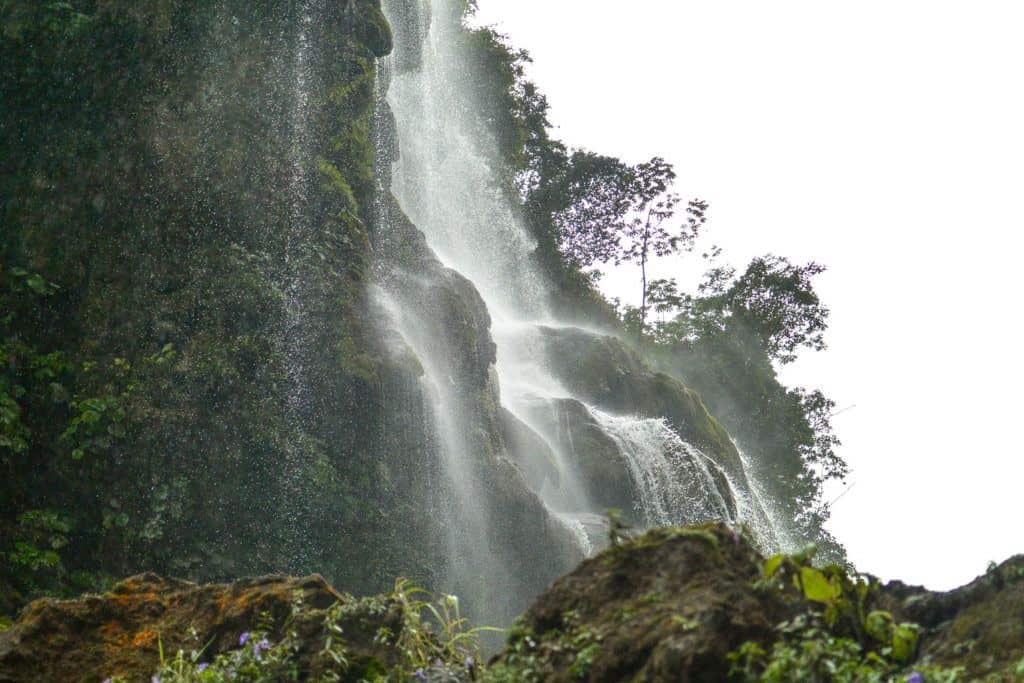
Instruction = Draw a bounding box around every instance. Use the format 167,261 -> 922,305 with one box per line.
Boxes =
479,0 -> 1024,589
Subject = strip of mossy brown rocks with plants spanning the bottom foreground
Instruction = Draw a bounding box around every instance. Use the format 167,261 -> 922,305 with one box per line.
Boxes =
0,524 -> 1024,683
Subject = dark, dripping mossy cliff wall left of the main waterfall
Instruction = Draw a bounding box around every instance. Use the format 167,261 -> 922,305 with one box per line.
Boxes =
0,0 -> 440,609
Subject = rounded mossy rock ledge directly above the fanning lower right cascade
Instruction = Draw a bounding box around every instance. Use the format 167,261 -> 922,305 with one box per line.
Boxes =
540,328 -> 745,481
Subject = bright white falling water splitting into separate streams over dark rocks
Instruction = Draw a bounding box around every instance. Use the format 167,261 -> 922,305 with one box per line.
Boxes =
378,0 -> 777,622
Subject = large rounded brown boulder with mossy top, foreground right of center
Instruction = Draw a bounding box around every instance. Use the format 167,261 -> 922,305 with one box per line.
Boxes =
493,524 -> 792,683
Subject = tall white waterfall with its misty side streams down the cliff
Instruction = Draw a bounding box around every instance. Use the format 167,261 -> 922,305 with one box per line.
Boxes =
377,0 -> 776,621
